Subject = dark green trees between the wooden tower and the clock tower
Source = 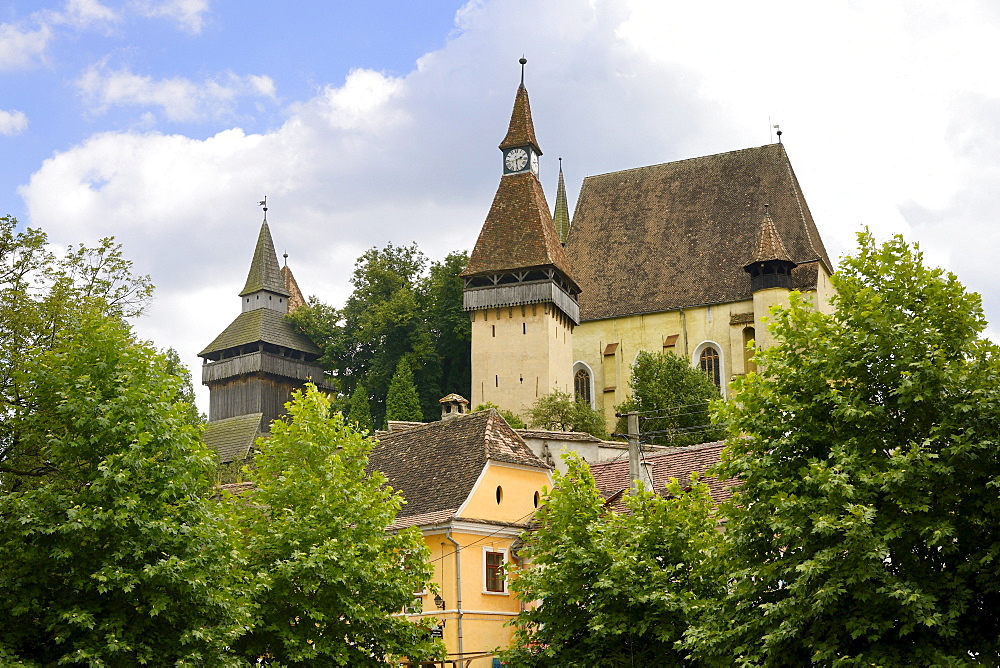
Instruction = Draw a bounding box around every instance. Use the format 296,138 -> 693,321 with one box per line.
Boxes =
289,244 -> 471,424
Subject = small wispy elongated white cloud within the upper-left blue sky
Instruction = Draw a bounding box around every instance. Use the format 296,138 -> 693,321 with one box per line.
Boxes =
75,65 -> 275,122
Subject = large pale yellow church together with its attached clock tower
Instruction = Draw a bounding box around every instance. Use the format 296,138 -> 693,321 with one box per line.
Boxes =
462,65 -> 832,424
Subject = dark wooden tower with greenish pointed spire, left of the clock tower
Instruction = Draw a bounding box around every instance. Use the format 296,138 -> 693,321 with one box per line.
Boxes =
198,208 -> 324,462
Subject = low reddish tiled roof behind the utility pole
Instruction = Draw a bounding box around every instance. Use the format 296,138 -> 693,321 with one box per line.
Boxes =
590,441 -> 737,502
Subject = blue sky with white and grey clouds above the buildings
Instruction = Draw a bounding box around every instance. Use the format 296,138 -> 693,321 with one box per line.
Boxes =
0,0 -> 1000,410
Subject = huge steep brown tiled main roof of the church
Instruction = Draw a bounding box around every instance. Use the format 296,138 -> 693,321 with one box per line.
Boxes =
566,144 -> 831,320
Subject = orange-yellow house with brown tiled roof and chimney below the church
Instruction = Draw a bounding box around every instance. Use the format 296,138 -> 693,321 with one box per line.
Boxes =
369,395 -> 552,667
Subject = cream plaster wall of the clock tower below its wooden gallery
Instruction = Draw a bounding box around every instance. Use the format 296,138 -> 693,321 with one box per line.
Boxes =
470,304 -> 574,415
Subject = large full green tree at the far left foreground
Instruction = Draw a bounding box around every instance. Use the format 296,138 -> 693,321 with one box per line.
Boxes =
0,310 -> 249,666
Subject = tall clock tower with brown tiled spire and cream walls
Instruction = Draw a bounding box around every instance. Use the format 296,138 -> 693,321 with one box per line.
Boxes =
462,58 -> 580,415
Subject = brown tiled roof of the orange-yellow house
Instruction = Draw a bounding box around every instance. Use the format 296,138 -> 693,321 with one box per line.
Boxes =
368,409 -> 549,525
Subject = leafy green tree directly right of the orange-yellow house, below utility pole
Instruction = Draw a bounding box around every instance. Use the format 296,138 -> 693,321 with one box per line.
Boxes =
502,456 -> 721,666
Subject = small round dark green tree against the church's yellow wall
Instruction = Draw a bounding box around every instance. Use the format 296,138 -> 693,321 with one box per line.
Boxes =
617,351 -> 726,446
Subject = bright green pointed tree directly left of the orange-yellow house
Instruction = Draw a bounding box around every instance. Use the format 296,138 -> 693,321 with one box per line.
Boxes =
230,384 -> 442,666
